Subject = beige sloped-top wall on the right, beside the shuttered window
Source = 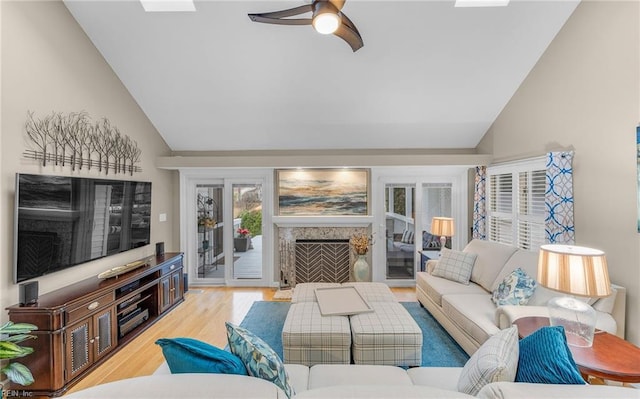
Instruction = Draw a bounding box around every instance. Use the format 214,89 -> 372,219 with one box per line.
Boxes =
478,1 -> 640,344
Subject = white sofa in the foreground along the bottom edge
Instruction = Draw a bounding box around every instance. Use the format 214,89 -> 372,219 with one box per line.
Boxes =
65,364 -> 640,399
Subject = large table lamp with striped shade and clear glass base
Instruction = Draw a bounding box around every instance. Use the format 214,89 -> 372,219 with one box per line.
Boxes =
538,244 -> 611,347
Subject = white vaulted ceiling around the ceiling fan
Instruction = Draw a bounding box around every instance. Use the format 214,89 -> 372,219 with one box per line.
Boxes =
65,0 -> 578,151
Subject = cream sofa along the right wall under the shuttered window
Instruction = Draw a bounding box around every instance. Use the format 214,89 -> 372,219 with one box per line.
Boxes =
416,240 -> 626,354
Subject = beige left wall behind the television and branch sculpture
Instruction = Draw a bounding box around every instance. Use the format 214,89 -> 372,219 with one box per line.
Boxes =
0,1 -> 180,319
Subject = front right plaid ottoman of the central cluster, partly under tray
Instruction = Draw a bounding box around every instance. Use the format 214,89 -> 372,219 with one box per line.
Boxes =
349,302 -> 422,367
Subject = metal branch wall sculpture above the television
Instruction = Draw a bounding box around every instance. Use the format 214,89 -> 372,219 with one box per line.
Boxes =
24,112 -> 142,175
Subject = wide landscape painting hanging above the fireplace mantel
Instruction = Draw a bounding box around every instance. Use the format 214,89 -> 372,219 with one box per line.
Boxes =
276,169 -> 369,216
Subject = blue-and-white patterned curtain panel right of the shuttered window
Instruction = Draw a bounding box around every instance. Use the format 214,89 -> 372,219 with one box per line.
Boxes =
544,151 -> 575,244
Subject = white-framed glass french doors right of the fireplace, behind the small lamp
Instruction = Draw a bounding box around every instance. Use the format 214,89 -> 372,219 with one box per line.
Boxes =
374,168 -> 467,285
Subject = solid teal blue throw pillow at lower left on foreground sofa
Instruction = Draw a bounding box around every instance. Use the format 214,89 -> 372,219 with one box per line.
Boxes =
156,338 -> 247,375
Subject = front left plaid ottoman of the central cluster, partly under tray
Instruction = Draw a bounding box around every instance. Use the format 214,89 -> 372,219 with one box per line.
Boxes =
282,304 -> 351,366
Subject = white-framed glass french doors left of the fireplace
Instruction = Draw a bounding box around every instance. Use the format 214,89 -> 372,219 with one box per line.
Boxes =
180,170 -> 273,286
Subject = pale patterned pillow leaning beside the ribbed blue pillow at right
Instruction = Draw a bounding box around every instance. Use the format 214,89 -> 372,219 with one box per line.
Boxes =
458,326 -> 518,396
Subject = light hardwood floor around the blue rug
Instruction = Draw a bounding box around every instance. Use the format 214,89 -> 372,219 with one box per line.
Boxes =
63,287 -> 416,392
